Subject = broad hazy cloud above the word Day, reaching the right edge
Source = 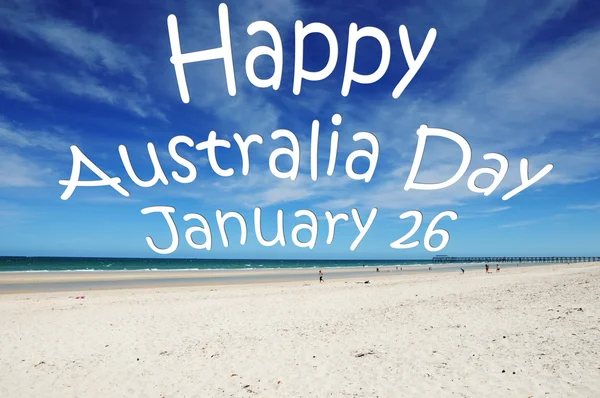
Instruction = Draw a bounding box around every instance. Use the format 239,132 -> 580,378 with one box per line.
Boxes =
364,24 -> 600,157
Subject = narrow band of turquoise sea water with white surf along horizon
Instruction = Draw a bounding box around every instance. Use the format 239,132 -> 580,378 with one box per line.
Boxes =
0,257 -> 440,272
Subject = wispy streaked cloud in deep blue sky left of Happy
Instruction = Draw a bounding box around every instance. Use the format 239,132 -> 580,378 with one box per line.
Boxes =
0,0 -> 167,121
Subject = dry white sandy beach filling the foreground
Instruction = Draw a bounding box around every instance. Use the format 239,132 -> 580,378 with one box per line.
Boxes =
0,263 -> 600,398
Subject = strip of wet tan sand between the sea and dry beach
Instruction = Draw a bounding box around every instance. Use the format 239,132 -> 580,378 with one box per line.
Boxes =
0,262 -> 600,295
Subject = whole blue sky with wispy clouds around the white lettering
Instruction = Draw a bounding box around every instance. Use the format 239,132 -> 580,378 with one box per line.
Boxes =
0,0 -> 600,259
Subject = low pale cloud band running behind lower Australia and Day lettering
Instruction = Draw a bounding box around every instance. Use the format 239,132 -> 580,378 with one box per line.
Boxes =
139,122 -> 600,214
